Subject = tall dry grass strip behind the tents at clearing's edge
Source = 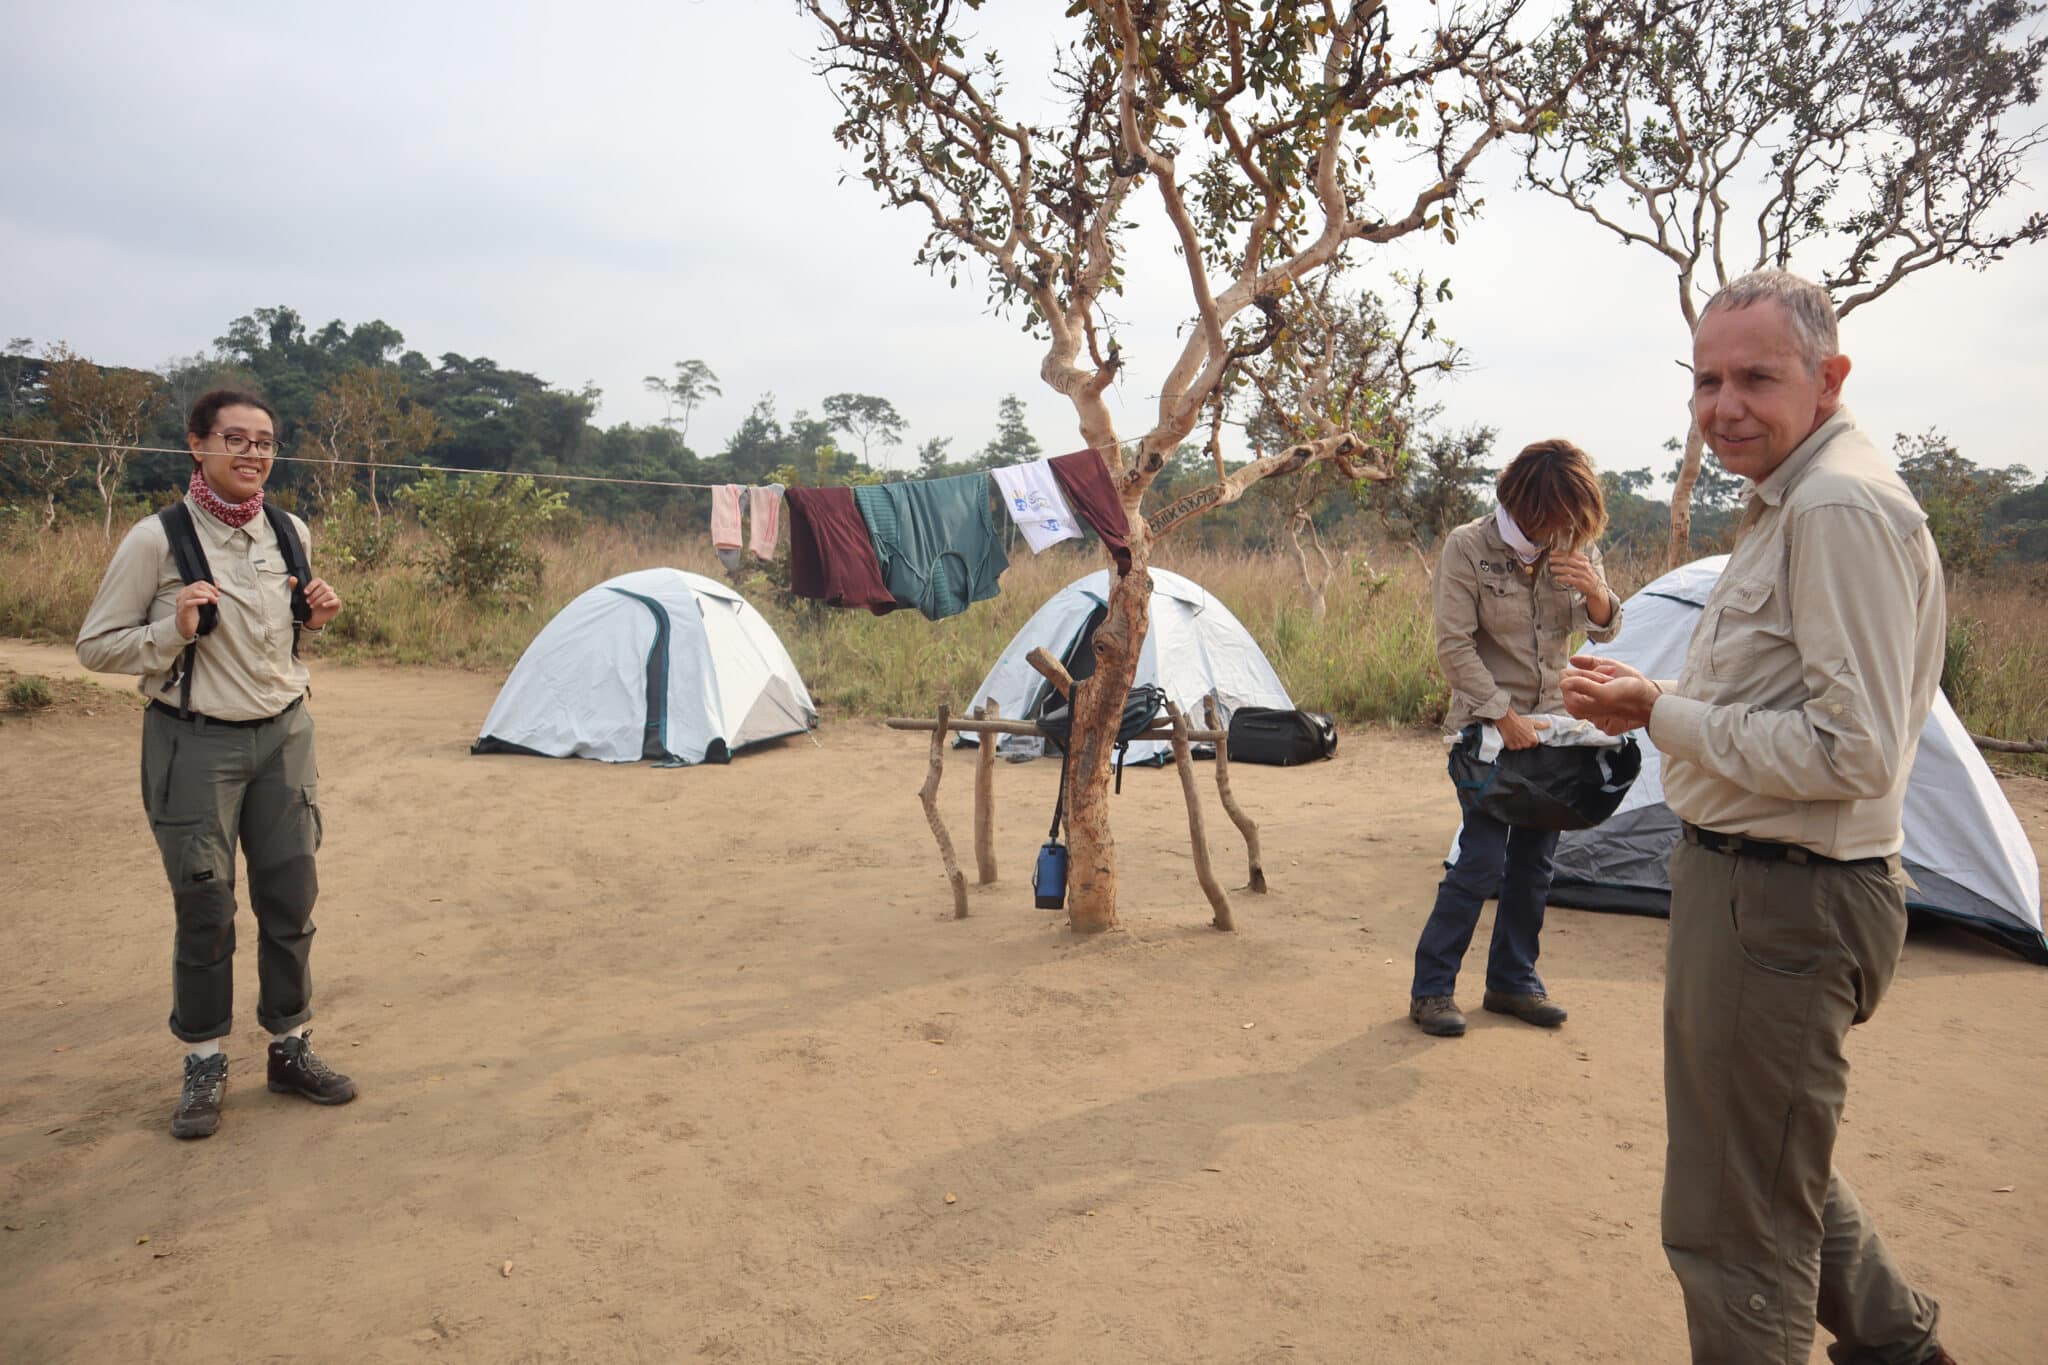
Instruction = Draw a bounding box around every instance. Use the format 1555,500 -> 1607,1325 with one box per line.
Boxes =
0,511 -> 2048,753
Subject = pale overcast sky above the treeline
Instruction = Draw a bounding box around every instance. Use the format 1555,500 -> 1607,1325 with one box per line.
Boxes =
0,0 -> 2048,485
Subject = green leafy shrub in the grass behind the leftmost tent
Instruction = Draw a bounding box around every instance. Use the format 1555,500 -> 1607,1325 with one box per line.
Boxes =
399,475 -> 569,602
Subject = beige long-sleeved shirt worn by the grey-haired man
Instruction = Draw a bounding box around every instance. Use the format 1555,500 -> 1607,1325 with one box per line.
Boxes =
1649,409 -> 1946,857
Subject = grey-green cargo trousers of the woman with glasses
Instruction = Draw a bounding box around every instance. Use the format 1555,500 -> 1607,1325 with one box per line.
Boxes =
141,706 -> 319,1044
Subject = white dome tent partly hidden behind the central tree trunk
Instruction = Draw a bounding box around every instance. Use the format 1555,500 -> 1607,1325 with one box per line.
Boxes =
958,569 -> 1294,763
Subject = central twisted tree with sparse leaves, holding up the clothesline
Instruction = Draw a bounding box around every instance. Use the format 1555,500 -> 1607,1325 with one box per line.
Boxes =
801,0 -> 1606,931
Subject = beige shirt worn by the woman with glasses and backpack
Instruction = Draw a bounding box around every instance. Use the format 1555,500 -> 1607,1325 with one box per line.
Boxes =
78,495 -> 313,720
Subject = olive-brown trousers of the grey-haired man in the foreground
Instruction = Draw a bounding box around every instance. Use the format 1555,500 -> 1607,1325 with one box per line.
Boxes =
1663,843 -> 1939,1365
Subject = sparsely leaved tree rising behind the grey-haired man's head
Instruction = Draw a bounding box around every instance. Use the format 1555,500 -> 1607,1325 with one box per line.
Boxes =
1526,0 -> 2048,565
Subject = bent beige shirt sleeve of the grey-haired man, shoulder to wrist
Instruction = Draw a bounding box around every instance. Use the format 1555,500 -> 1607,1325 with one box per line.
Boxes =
1649,505 -> 1921,800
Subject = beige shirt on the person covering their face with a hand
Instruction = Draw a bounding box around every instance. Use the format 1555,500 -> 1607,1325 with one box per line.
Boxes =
1434,512 -> 1622,735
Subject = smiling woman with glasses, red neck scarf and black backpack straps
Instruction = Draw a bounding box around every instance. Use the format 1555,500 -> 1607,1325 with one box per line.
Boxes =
78,389 -> 356,1138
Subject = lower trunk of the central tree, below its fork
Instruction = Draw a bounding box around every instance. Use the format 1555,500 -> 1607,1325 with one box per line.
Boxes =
1067,527 -> 1151,933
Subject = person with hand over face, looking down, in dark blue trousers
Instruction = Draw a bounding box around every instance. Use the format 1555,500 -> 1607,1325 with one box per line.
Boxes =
1409,440 -> 1622,1038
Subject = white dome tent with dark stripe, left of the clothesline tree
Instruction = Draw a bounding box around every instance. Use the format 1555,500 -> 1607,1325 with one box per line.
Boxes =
469,569 -> 817,763
